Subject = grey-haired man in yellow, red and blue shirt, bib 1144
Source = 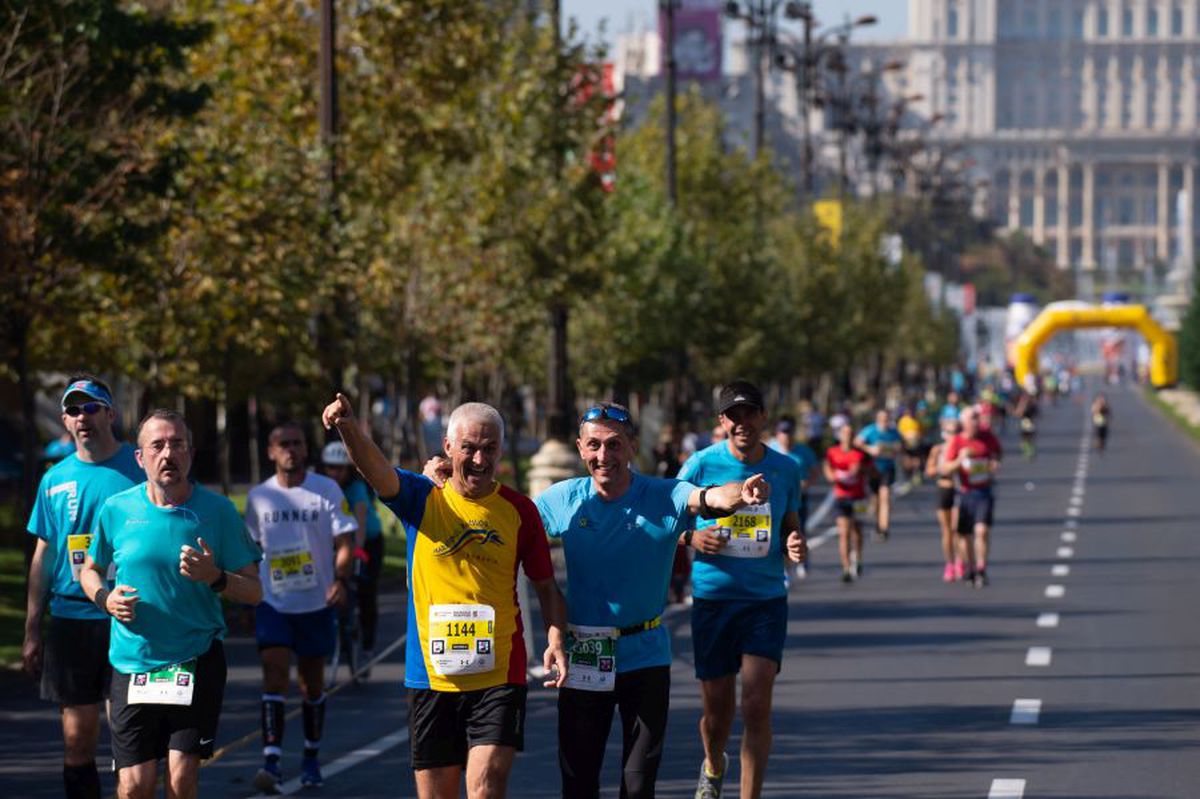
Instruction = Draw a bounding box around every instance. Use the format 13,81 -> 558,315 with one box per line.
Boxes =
322,394 -> 564,799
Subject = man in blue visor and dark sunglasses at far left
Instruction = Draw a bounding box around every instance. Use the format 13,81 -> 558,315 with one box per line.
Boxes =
22,374 -> 145,799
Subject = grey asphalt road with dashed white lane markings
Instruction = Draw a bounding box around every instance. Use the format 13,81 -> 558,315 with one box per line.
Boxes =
7,389 -> 1200,799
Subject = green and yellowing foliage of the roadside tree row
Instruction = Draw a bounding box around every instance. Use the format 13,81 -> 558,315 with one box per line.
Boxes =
0,0 -> 954,484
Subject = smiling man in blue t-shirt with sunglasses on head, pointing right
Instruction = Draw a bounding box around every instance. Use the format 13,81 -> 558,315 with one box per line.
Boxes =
535,403 -> 768,799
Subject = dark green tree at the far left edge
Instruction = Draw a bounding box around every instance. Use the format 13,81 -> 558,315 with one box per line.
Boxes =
0,0 -> 208,511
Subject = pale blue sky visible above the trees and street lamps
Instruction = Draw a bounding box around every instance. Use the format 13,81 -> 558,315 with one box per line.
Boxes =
562,0 -> 908,44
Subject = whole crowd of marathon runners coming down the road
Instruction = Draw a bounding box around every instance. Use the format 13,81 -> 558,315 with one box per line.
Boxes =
23,374 -> 1110,799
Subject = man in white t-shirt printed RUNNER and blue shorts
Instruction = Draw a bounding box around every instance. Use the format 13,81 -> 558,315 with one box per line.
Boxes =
246,423 -> 358,793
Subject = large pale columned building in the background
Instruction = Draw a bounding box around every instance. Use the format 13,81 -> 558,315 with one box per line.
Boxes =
892,0 -> 1200,288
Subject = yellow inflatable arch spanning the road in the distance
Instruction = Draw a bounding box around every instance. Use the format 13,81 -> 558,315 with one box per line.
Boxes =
1013,305 -> 1180,389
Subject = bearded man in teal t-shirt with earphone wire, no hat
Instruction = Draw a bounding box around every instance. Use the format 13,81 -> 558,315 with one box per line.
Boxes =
79,410 -> 263,798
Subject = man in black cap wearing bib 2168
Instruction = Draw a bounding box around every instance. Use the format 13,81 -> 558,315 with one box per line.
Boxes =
679,380 -> 806,797
